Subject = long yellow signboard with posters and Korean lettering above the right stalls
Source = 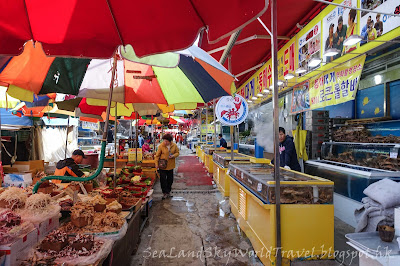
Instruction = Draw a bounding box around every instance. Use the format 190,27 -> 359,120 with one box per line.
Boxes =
238,0 -> 400,109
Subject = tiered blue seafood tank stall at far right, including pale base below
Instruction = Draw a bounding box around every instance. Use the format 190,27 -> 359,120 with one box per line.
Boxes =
305,126 -> 400,226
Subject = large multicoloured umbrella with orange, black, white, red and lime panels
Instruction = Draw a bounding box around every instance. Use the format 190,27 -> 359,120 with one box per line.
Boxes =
0,42 -> 235,109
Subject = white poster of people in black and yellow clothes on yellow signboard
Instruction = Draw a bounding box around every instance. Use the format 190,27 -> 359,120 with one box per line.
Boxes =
322,0 -> 357,63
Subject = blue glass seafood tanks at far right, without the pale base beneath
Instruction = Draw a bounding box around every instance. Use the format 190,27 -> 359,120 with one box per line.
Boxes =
305,141 -> 400,202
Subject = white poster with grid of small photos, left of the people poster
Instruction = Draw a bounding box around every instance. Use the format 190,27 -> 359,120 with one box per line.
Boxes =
298,22 -> 321,69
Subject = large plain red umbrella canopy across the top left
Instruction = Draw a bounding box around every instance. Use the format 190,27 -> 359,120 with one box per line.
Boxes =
0,0 -> 268,58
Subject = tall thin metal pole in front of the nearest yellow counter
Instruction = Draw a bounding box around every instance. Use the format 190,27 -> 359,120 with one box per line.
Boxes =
270,0 -> 282,265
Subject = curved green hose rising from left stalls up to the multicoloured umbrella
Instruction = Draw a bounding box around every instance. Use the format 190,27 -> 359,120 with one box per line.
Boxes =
32,54 -> 117,194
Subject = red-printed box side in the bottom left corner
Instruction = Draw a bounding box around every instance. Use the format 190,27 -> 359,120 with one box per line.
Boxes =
0,229 -> 38,266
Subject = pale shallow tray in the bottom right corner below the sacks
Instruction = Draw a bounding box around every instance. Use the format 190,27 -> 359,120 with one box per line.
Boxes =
345,232 -> 400,257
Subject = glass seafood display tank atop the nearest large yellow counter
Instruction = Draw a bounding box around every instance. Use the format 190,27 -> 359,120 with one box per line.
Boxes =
228,162 -> 333,204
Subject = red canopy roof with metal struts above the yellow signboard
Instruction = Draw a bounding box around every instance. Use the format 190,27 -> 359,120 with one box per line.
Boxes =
199,0 -> 326,88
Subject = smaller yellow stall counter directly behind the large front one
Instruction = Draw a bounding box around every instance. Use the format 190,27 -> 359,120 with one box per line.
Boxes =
212,152 -> 251,197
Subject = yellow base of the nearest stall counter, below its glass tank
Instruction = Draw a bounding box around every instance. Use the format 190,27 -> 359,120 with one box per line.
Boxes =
227,165 -> 334,265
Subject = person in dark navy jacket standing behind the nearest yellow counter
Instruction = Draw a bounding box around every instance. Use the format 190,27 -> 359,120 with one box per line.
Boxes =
279,127 -> 301,172
